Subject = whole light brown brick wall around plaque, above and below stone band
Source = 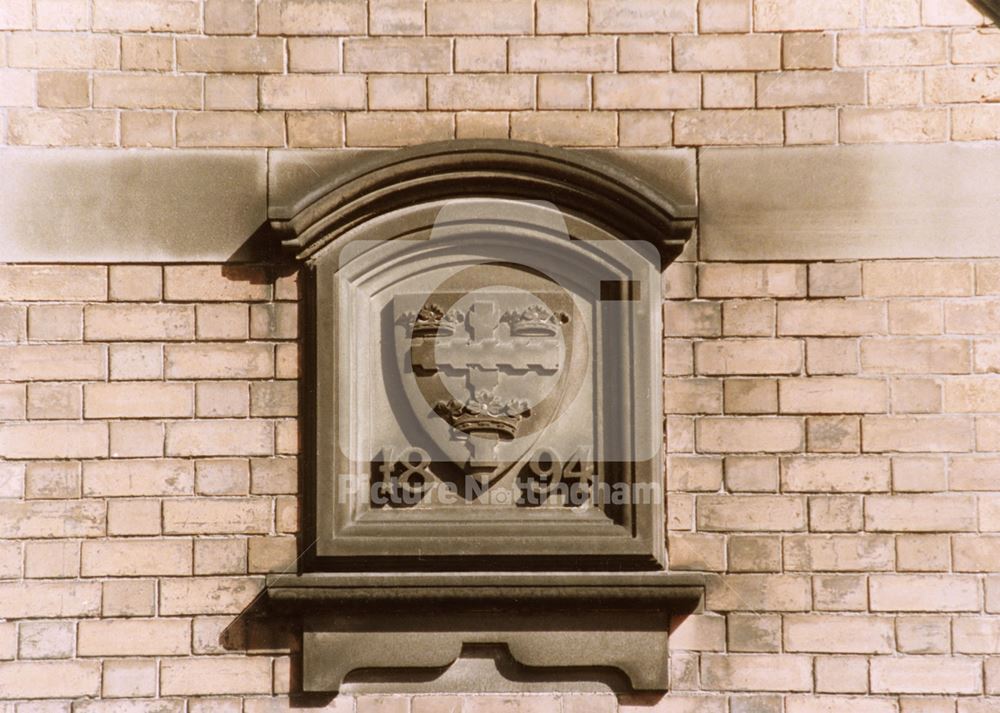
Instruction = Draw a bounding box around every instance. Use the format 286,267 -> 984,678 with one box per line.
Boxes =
0,0 -> 1000,713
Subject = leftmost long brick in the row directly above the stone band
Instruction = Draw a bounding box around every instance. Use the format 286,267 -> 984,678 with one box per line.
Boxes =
7,109 -> 116,146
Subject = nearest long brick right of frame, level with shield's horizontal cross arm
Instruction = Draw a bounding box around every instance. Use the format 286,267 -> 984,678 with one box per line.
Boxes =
695,339 -> 802,376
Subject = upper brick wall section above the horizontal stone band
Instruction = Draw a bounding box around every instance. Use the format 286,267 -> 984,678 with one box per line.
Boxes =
0,0 -> 1000,147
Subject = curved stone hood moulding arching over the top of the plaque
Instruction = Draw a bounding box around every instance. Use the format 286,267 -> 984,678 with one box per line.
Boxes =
271,140 -> 697,264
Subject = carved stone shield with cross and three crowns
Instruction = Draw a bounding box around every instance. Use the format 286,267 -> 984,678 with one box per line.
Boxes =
392,272 -> 587,496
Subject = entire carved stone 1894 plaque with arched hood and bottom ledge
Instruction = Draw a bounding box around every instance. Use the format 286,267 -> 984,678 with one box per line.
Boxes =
267,141 -> 704,691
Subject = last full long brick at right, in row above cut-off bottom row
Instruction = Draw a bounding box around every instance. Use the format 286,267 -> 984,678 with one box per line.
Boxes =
871,656 -> 983,694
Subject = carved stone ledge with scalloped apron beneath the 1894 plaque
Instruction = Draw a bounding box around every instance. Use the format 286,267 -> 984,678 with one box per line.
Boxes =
267,572 -> 705,692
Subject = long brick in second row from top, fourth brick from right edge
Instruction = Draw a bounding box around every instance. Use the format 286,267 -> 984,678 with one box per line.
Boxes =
674,34 -> 781,72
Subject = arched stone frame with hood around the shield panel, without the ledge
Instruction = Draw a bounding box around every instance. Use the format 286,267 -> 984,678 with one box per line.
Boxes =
275,141 -> 691,570
